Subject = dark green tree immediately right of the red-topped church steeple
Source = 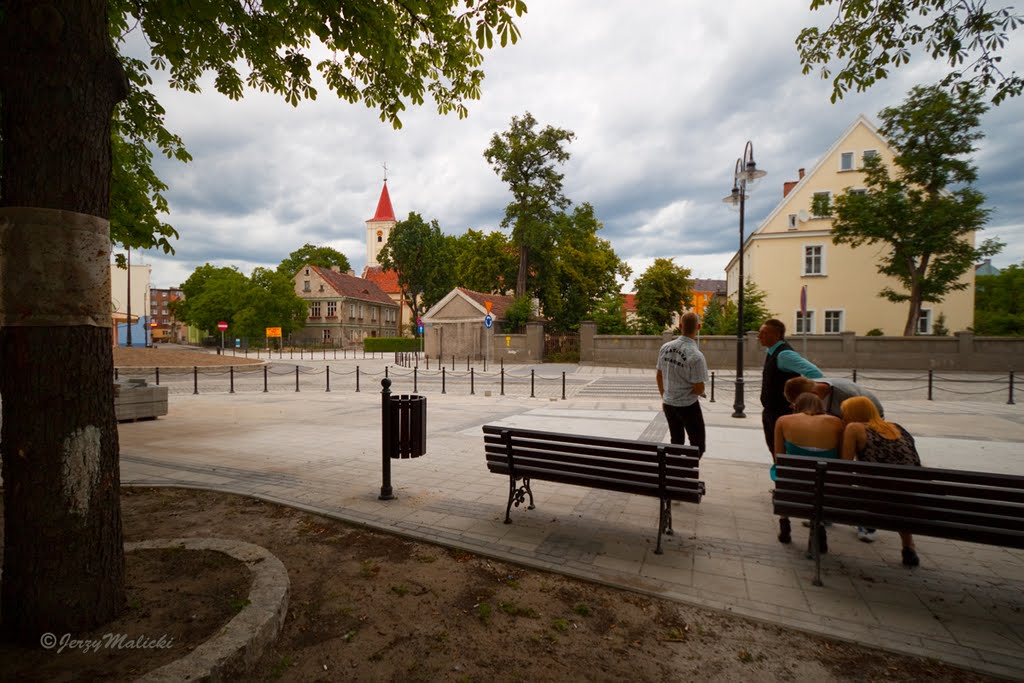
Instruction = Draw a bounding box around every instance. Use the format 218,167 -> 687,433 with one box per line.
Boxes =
377,212 -> 457,331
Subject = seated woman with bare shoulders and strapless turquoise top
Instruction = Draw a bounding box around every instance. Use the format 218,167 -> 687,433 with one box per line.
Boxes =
771,392 -> 843,552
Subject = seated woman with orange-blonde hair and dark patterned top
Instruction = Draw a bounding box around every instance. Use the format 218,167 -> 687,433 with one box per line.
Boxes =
842,396 -> 921,567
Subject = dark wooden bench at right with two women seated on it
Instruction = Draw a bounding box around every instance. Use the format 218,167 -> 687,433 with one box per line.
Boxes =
774,456 -> 1024,586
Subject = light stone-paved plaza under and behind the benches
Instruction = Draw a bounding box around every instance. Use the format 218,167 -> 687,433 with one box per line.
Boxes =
120,360 -> 1024,679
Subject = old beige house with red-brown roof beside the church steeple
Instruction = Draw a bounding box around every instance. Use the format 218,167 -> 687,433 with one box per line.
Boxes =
292,264 -> 398,346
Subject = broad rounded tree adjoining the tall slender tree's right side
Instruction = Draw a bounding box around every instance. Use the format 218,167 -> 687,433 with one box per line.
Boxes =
535,203 -> 632,330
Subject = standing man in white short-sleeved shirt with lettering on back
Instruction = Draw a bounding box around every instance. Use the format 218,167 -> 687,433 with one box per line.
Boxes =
657,312 -> 708,456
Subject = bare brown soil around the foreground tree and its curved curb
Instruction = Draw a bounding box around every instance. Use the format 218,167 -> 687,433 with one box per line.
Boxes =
0,488 -> 993,683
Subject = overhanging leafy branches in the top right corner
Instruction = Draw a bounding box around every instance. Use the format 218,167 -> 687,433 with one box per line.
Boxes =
797,0 -> 1024,104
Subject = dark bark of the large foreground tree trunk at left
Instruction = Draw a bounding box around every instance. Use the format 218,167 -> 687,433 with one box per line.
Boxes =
0,0 -> 126,643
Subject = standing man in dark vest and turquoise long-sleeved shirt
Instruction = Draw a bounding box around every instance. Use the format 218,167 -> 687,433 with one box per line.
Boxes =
758,317 -> 822,459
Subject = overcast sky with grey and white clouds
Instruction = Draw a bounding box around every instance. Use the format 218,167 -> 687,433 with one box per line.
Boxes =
133,0 -> 1024,290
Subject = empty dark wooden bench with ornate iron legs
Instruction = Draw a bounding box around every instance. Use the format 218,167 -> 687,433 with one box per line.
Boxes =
483,425 -> 705,554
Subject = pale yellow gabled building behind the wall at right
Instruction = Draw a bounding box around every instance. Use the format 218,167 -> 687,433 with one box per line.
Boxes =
726,116 -> 974,336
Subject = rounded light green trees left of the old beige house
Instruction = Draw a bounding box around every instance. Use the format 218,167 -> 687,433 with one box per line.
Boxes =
171,263 -> 306,339
